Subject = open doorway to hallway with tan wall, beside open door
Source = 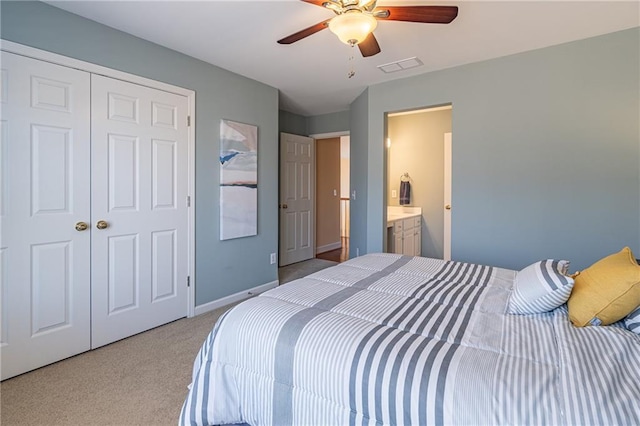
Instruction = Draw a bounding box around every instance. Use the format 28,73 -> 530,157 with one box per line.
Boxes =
315,136 -> 350,262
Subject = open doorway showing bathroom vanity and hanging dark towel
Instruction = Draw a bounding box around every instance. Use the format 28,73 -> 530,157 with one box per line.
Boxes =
386,105 -> 453,260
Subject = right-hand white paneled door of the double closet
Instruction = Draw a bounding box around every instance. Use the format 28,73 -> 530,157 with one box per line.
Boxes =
91,75 -> 188,348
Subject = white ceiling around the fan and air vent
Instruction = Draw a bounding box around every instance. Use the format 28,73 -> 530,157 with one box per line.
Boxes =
47,0 -> 640,116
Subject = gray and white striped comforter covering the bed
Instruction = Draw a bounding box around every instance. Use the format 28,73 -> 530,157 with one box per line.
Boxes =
180,254 -> 640,426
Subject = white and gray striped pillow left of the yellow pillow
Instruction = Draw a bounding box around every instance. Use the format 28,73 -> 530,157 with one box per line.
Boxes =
508,259 -> 574,314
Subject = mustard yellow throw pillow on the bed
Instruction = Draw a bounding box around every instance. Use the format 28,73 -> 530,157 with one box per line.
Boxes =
567,247 -> 640,327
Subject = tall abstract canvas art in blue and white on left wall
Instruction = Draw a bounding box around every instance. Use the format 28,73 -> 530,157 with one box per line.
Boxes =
220,120 -> 258,240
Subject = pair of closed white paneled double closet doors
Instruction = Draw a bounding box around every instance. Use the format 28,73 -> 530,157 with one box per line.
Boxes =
0,52 -> 188,379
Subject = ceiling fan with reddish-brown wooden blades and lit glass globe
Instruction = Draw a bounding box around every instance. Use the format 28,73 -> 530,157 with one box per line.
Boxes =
278,0 -> 458,57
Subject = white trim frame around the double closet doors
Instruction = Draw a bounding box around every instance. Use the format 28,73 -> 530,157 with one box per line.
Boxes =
0,39 -> 196,318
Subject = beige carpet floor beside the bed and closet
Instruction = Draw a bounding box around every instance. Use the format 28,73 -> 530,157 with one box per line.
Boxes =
0,259 -> 335,426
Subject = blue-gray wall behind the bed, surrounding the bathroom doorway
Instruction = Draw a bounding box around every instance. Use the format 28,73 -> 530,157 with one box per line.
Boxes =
351,28 -> 640,270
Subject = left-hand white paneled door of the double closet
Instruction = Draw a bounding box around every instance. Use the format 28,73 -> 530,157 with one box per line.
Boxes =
0,52 -> 91,380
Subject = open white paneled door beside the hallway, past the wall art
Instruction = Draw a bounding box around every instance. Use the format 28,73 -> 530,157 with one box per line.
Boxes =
280,133 -> 315,266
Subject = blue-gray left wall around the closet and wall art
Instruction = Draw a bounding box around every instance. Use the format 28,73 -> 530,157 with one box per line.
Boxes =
0,1 -> 278,305
